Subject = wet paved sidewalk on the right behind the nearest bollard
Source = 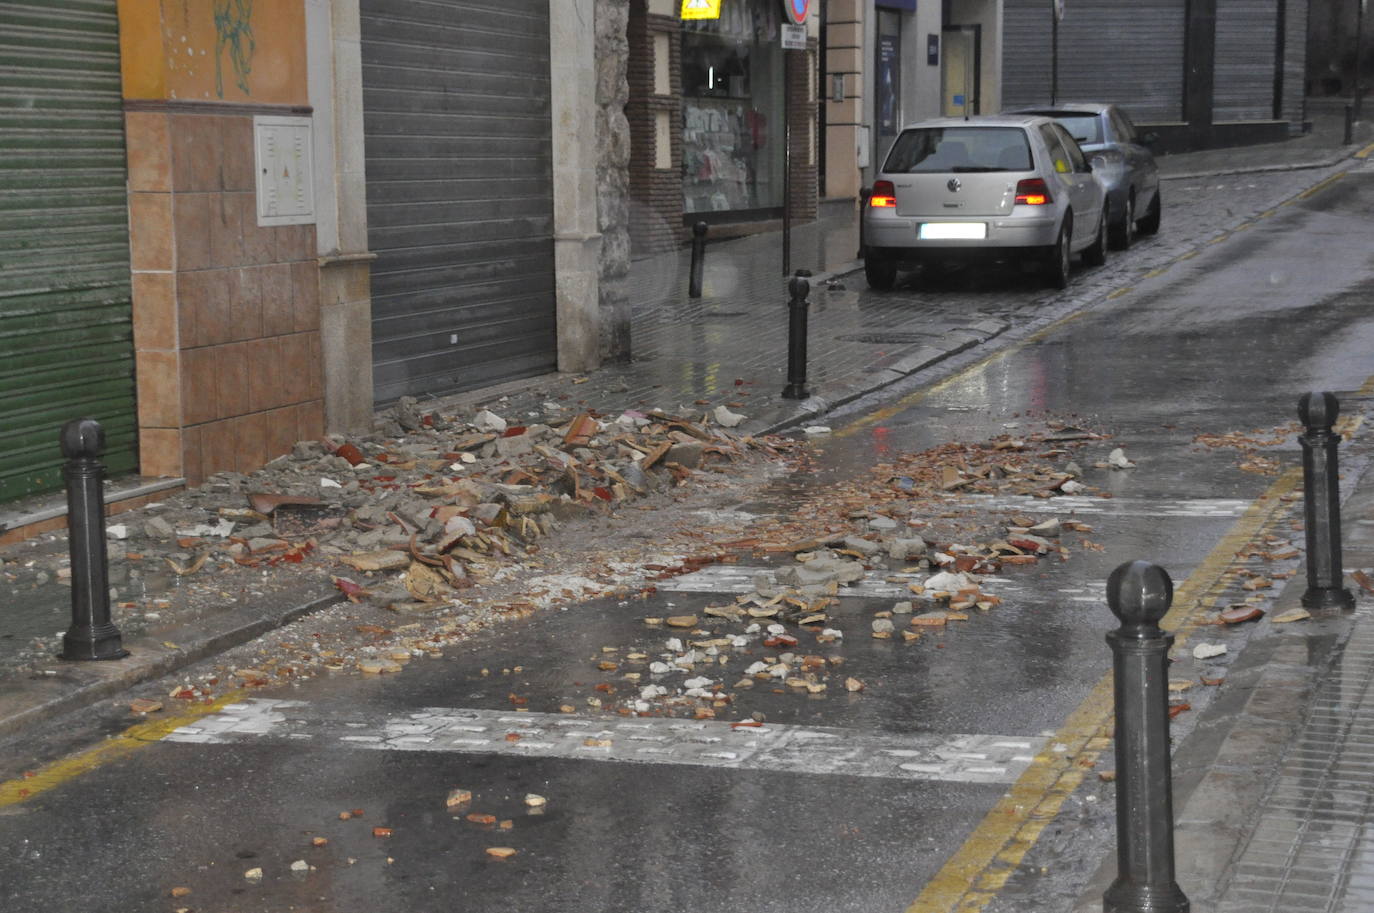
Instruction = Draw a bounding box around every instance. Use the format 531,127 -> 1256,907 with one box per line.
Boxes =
1072,415 -> 1374,913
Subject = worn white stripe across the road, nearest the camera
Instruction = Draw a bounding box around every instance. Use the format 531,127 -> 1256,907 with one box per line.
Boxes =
166,699 -> 1046,784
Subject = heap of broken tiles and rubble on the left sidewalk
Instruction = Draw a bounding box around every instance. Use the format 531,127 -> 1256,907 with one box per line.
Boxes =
126,400 -> 782,615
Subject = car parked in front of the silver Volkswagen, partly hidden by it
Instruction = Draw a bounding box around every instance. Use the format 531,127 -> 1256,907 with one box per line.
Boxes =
1013,102 -> 1160,250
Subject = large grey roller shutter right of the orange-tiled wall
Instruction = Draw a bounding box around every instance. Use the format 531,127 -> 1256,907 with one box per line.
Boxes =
361,0 -> 556,402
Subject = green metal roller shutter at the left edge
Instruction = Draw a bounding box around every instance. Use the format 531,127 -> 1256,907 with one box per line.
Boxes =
0,0 -> 137,501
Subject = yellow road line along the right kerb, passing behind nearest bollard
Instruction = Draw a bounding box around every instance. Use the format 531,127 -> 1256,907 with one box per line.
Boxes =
907,469 -> 1303,913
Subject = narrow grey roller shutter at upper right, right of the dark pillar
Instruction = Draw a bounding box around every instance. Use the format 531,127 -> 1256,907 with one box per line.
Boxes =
1212,0 -> 1275,124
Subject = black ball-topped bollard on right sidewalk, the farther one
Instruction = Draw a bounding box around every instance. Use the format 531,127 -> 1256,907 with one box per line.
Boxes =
1297,393 -> 1355,609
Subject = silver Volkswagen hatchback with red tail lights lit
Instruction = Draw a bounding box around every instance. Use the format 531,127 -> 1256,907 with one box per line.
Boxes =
863,116 -> 1106,289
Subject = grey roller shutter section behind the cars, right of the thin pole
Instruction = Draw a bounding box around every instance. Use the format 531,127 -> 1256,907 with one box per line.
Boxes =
1058,0 -> 1187,124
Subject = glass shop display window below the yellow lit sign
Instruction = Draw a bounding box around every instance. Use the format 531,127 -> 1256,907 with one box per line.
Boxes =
682,0 -> 783,213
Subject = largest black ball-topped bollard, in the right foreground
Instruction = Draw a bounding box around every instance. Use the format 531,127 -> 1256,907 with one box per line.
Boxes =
1102,561 -> 1191,913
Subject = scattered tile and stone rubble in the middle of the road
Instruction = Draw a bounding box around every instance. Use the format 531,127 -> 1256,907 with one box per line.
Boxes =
563,424 -> 1134,725
